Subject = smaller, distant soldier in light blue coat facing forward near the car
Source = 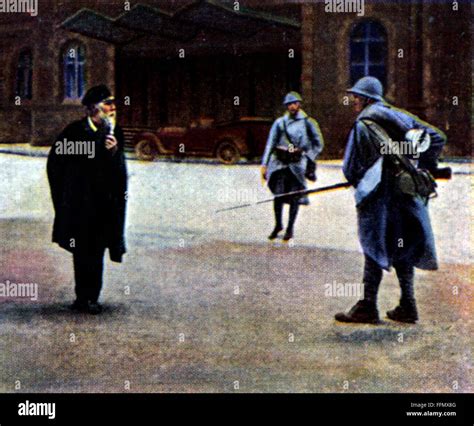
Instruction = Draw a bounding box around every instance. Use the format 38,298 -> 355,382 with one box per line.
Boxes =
262,92 -> 324,241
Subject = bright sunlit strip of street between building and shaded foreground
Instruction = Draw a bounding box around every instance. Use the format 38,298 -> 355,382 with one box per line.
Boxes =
0,150 -> 473,264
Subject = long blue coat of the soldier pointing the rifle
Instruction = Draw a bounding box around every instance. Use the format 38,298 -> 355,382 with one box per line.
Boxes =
343,102 -> 446,270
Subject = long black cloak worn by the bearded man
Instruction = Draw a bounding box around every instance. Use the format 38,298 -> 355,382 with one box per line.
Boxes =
47,118 -> 127,262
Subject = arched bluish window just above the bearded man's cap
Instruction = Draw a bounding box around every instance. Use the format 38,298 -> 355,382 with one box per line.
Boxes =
63,43 -> 86,99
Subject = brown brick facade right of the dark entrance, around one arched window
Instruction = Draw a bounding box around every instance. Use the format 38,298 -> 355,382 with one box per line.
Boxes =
302,0 -> 472,157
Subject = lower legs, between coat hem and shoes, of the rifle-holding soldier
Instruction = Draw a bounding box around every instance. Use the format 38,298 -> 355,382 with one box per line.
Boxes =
363,256 -> 415,306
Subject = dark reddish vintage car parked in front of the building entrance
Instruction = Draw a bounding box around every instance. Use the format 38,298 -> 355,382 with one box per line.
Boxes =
132,117 -> 273,164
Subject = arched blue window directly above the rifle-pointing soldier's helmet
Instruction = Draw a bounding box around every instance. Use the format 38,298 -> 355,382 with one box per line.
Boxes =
350,21 -> 387,87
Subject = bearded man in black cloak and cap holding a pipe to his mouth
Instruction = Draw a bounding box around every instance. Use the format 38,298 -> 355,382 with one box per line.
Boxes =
47,85 -> 127,314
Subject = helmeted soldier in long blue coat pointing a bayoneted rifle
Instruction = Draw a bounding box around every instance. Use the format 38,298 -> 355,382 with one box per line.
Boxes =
336,77 -> 446,323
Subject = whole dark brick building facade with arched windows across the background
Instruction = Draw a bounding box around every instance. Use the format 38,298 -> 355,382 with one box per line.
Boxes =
0,0 -> 472,158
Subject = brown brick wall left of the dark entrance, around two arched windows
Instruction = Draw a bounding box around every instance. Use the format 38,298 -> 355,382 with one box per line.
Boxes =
0,5 -> 115,145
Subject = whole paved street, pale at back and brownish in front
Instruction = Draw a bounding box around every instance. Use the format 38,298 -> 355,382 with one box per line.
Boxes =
0,154 -> 473,392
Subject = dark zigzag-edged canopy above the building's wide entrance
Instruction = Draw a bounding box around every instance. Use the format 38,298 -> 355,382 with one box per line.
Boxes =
61,0 -> 300,57
